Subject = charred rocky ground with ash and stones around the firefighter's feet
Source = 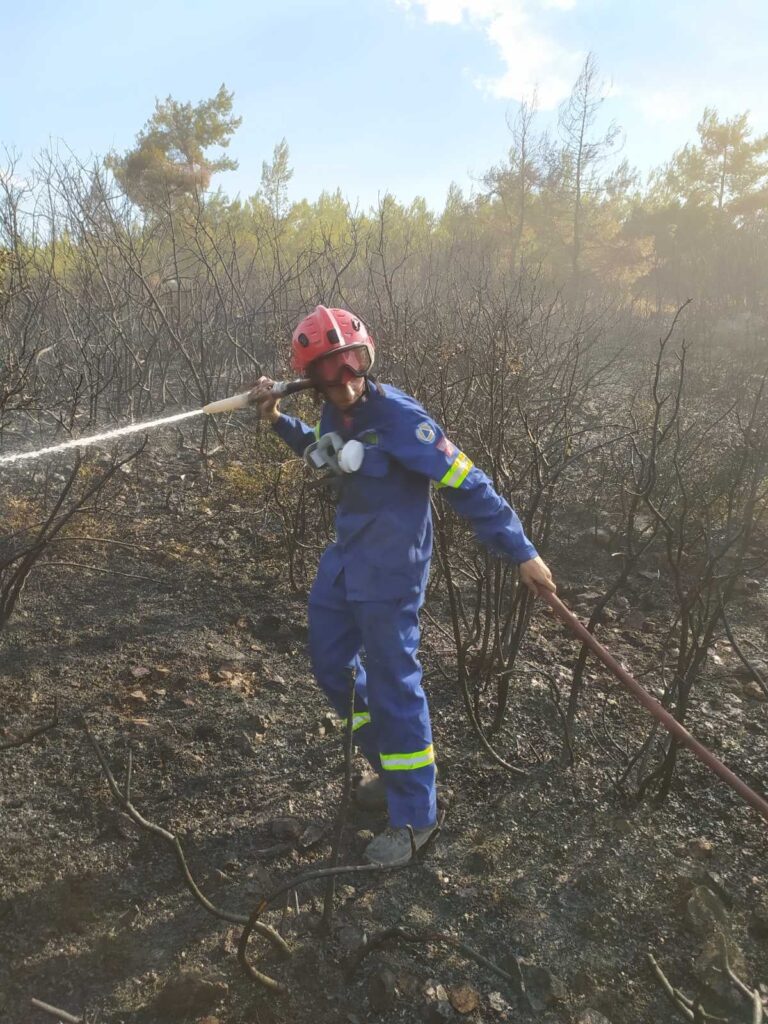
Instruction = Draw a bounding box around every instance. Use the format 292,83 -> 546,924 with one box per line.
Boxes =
0,446 -> 768,1024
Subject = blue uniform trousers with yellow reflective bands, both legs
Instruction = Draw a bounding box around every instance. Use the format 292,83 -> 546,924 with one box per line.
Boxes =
309,550 -> 437,828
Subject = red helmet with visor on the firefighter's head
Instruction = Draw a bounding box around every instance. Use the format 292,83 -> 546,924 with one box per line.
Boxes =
291,306 -> 375,384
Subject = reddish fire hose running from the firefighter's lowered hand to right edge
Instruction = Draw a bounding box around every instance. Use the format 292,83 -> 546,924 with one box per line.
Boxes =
539,588 -> 768,821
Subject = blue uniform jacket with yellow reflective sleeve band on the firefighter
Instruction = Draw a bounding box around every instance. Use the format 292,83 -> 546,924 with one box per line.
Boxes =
273,381 -> 537,601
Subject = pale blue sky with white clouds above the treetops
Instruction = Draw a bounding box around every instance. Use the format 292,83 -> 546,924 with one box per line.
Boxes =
0,0 -> 768,208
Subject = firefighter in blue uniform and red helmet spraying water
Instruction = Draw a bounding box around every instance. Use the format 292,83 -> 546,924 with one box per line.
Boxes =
252,306 -> 555,866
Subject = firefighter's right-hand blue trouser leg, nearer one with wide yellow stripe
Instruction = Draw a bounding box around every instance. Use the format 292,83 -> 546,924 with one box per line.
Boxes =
351,597 -> 437,828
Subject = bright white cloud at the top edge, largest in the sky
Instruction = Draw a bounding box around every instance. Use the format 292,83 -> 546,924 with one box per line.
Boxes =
395,0 -> 585,110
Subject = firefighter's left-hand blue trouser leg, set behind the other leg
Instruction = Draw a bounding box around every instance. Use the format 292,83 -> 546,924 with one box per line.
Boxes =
309,556 -> 381,772
